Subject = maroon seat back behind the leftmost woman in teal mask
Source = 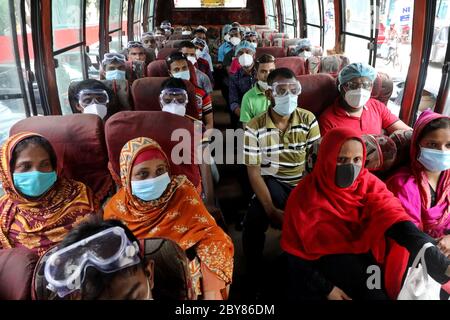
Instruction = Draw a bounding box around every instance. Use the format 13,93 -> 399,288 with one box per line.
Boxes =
10,114 -> 114,201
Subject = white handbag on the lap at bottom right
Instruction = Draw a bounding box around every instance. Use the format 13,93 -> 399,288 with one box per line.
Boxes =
397,242 -> 441,300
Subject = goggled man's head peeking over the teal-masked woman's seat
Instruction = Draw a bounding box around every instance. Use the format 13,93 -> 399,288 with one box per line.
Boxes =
68,79 -> 119,121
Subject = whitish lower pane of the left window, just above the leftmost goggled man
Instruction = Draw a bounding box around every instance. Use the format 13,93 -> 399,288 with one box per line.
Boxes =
55,47 -> 83,114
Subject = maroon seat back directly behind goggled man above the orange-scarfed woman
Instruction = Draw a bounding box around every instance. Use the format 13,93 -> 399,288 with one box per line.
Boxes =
131,77 -> 199,119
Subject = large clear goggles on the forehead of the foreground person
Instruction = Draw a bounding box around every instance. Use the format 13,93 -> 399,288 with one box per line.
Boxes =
44,227 -> 141,298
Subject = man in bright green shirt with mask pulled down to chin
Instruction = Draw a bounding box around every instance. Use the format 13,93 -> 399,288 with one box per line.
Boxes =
240,54 -> 276,127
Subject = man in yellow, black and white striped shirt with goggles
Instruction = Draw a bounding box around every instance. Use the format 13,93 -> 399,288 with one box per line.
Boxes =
242,68 -> 320,294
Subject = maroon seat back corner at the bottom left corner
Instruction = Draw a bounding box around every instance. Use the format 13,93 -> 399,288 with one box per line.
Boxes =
0,248 -> 38,300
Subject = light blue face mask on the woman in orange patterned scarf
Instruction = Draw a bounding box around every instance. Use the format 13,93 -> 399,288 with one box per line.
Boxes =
131,172 -> 170,201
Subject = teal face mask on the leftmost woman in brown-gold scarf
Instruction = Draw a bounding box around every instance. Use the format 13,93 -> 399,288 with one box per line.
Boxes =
13,171 -> 57,198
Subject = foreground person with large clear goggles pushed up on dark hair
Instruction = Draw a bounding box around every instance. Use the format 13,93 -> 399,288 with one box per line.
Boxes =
39,220 -> 154,300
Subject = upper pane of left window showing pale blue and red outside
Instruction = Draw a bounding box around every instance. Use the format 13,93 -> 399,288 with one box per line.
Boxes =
52,0 -> 82,51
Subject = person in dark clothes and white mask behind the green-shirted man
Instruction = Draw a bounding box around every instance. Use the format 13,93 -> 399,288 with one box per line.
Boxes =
229,41 -> 257,122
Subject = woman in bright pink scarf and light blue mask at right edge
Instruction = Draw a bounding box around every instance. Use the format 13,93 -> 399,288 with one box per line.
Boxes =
386,110 -> 450,295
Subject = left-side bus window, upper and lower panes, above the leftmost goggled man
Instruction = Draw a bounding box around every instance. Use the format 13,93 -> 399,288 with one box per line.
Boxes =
52,0 -> 83,114
